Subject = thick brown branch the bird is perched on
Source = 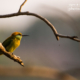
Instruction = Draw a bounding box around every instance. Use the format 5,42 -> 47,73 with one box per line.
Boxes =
0,43 -> 24,66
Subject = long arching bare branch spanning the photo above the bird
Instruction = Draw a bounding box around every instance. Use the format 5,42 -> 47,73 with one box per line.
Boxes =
0,11 -> 80,42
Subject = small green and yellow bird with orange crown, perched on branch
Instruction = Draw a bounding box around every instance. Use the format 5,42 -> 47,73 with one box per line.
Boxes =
0,32 -> 29,55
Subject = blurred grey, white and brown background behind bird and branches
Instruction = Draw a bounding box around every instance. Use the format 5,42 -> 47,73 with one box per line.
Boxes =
0,0 -> 80,80
